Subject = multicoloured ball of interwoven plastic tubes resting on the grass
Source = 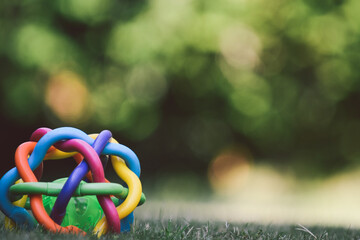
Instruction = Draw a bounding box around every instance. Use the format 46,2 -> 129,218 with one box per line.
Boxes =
0,127 -> 145,237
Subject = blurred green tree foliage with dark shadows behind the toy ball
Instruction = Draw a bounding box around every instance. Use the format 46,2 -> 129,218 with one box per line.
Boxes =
0,0 -> 360,174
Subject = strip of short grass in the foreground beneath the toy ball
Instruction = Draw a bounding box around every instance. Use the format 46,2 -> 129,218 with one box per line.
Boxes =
0,216 -> 360,240
